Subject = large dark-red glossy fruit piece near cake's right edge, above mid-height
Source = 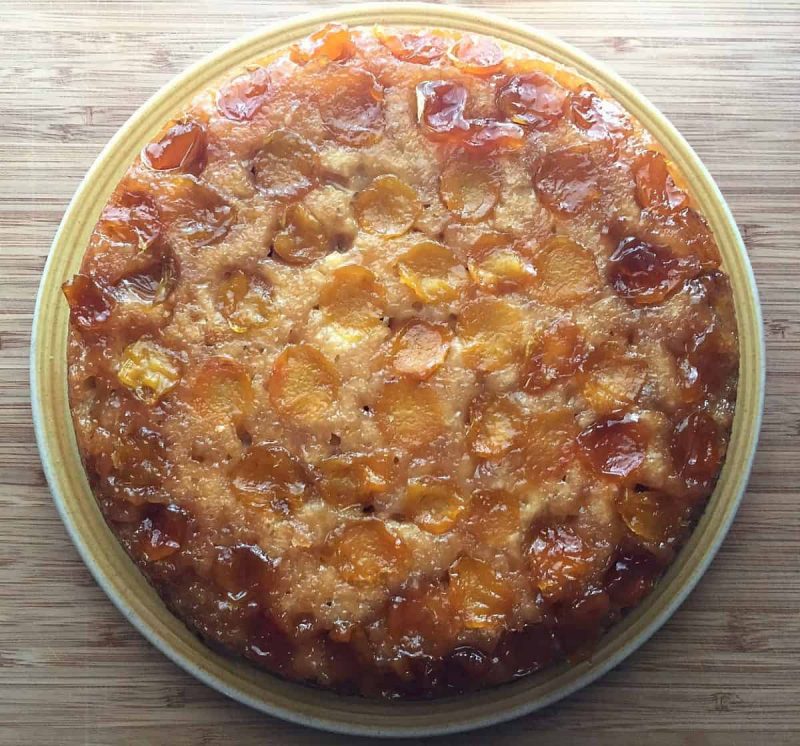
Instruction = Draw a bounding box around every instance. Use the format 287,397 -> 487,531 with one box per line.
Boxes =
607,236 -> 700,306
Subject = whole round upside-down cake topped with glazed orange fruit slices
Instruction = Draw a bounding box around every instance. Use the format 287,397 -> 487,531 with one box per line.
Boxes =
64,24 -> 738,697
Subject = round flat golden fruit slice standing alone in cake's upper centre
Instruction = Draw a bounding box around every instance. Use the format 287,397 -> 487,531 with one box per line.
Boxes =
353,174 -> 422,236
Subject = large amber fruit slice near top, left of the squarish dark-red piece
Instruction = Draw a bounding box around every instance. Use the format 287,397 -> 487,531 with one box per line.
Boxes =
315,65 -> 384,147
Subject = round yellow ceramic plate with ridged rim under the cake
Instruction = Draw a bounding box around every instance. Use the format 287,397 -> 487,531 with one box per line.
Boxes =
31,3 -> 764,736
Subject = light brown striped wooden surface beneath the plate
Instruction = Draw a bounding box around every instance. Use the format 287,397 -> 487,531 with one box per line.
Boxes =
0,0 -> 800,746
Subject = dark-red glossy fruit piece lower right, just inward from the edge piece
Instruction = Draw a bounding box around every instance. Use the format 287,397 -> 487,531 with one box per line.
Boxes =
578,415 -> 647,479
